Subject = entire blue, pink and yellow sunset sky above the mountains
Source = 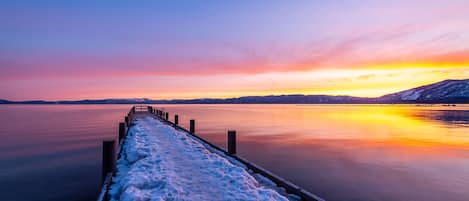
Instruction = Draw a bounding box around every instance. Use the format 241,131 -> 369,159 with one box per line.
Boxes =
0,0 -> 469,100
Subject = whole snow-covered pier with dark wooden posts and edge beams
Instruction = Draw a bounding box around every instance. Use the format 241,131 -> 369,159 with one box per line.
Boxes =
98,106 -> 322,201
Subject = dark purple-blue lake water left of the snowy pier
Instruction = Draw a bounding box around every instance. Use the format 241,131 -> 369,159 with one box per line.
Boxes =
0,105 -> 130,201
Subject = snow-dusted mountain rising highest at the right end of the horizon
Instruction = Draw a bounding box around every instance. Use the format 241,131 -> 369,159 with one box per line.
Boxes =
378,79 -> 469,103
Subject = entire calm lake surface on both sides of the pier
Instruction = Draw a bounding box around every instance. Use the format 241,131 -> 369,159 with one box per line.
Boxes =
0,105 -> 469,201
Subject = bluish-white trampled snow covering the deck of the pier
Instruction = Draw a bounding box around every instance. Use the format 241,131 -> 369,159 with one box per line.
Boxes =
109,116 -> 294,201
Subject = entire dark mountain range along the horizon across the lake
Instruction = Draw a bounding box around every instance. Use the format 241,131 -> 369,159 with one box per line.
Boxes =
0,79 -> 469,104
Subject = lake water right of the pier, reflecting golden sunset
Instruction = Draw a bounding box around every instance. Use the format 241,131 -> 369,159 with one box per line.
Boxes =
158,105 -> 469,201
